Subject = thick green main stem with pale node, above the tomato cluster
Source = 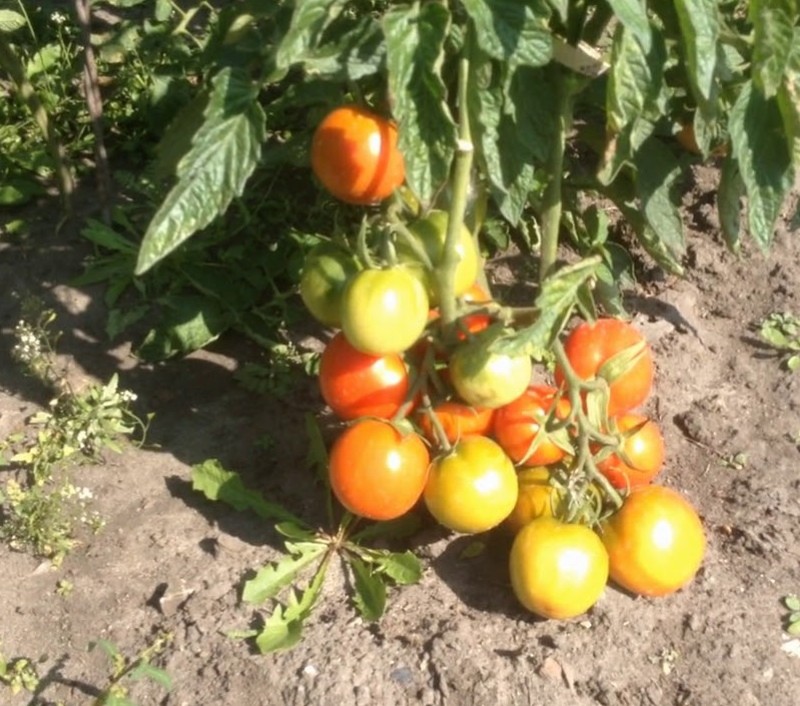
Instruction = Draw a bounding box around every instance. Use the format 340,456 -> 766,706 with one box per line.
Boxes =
436,56 -> 474,331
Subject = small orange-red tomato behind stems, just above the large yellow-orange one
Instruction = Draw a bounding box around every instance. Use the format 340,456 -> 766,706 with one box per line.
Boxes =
597,414 -> 664,490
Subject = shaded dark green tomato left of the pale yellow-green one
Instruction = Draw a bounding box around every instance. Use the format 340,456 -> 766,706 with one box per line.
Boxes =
300,241 -> 360,328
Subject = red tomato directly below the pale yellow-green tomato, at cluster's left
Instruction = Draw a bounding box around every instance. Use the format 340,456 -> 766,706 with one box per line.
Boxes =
319,331 -> 409,420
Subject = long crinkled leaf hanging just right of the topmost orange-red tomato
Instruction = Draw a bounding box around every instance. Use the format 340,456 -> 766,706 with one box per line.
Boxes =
383,3 -> 456,204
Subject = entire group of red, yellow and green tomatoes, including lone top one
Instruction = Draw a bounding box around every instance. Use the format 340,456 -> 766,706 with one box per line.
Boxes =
301,106 -> 705,618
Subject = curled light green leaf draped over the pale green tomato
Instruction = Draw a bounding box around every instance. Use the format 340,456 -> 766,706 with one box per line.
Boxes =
489,256 -> 601,356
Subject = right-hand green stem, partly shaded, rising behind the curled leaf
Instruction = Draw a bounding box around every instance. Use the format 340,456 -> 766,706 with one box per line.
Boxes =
539,65 -> 573,282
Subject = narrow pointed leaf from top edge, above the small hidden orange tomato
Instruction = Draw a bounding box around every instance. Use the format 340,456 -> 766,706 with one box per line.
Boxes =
675,0 -> 720,106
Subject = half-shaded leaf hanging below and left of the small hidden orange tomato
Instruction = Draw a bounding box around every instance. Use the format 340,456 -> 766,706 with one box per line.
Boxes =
634,137 -> 686,261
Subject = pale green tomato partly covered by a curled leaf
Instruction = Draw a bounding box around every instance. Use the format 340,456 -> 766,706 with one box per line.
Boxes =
448,338 -> 533,409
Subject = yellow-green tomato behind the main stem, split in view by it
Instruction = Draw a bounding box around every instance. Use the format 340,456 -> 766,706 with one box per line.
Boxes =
397,206 -> 479,306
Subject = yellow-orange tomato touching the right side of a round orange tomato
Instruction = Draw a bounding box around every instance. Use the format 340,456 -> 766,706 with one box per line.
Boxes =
423,436 -> 518,533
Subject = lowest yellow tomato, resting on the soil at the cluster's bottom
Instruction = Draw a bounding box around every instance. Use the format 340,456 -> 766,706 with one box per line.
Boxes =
509,517 -> 608,620
